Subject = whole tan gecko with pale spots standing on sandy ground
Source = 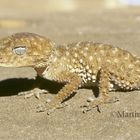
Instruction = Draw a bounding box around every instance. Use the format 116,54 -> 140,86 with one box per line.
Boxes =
0,33 -> 140,114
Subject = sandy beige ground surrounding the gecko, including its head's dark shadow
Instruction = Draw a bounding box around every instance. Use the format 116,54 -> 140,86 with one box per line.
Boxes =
0,0 -> 140,140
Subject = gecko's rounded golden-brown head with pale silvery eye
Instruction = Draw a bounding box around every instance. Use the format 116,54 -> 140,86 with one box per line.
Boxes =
0,33 -> 54,67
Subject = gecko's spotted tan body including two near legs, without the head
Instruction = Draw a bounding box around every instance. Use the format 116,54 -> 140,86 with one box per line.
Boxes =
42,42 -> 140,114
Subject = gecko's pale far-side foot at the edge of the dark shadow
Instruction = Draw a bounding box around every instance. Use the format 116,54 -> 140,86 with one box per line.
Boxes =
18,88 -> 47,99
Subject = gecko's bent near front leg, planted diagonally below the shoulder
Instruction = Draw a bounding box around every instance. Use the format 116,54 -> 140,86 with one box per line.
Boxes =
43,72 -> 82,115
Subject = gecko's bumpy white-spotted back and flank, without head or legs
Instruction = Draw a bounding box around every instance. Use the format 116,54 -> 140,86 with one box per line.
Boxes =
52,42 -> 140,90
